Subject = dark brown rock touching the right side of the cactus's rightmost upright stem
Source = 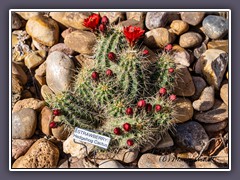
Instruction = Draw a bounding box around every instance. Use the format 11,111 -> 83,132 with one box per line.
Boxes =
174,65 -> 195,96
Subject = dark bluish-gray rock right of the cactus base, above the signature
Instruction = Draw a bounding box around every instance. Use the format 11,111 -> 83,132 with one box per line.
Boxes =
174,121 -> 209,151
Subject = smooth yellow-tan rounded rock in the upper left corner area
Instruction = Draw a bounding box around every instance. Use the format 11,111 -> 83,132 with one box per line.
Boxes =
26,16 -> 59,46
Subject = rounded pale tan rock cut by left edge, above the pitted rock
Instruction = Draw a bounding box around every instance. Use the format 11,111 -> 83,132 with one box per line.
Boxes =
12,108 -> 37,139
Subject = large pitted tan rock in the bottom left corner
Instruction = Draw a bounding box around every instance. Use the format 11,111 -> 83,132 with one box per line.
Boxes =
12,138 -> 59,168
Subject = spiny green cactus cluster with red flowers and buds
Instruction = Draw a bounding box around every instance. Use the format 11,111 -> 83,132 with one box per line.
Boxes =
48,14 -> 176,150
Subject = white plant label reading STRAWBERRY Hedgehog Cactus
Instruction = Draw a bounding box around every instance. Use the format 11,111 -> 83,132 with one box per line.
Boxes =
73,127 -> 111,149
